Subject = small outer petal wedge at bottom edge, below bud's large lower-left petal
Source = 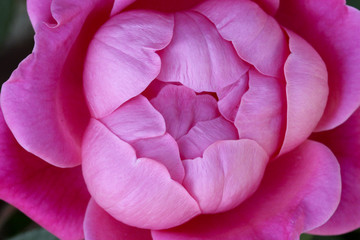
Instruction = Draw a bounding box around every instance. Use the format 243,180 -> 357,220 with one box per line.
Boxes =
84,199 -> 152,240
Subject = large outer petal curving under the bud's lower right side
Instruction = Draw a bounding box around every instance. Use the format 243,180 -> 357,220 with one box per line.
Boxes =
152,141 -> 341,240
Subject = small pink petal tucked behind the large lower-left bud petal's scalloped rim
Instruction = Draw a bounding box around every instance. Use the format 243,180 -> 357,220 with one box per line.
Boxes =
131,133 -> 185,183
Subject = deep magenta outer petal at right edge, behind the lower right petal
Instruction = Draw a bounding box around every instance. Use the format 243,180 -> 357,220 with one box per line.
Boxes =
312,109 -> 360,235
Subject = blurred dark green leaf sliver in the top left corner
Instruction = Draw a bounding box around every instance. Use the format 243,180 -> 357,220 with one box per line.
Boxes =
0,0 -> 16,48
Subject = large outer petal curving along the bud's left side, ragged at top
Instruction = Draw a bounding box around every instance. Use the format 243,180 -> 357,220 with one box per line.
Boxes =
1,0 -> 119,167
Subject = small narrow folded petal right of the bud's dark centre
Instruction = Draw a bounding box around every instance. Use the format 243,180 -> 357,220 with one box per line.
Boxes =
217,74 -> 249,122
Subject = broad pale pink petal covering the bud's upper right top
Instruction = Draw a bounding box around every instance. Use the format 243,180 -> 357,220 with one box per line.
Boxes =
195,0 -> 289,77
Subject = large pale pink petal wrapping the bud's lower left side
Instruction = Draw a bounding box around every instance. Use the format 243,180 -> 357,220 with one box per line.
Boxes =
82,119 -> 200,229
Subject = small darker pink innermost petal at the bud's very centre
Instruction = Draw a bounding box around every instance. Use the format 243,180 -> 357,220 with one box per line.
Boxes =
150,85 -> 219,140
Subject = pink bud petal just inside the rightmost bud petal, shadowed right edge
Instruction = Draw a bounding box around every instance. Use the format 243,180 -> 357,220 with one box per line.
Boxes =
235,70 -> 286,156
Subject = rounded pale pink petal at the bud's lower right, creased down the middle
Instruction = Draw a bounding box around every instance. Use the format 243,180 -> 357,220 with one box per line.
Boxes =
183,140 -> 269,213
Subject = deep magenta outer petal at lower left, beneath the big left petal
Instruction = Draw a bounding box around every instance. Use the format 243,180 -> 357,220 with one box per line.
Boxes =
0,107 -> 90,240
